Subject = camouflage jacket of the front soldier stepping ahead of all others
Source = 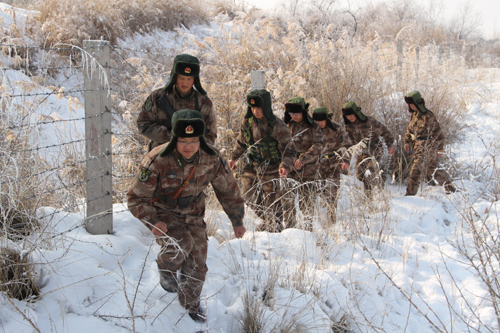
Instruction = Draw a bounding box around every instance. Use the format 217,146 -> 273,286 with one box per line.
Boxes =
127,145 -> 244,229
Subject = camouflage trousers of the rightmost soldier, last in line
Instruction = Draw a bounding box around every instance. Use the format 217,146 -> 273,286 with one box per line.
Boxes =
405,149 -> 455,195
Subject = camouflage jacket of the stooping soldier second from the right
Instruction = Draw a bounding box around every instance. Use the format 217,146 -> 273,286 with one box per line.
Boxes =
345,116 -> 394,155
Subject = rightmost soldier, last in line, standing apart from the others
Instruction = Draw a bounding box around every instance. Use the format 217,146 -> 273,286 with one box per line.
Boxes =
404,91 -> 455,195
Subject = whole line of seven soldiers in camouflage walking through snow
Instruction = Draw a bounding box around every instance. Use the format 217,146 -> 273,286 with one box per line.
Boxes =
127,54 -> 455,322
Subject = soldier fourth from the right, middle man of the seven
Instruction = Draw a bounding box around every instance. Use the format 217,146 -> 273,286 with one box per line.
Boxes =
284,97 -> 323,229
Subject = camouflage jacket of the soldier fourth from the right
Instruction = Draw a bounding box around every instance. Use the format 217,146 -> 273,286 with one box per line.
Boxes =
288,120 -> 323,179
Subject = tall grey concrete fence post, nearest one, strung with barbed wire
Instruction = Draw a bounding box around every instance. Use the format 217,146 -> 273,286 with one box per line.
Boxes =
83,40 -> 113,235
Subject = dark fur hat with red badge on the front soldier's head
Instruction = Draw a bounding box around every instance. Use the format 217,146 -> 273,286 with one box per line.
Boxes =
160,109 -> 217,157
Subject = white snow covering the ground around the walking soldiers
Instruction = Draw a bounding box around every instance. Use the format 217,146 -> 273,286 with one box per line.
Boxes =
0,3 -> 500,333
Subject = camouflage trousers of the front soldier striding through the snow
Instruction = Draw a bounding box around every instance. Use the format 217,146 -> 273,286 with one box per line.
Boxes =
156,220 -> 208,312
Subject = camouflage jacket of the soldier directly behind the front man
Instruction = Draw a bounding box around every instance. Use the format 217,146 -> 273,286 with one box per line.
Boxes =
137,87 -> 217,150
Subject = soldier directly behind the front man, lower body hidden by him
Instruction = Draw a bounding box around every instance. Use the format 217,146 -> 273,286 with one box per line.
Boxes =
137,54 -> 217,151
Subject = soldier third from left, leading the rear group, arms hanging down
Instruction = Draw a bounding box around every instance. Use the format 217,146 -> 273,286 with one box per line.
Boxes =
229,89 -> 295,232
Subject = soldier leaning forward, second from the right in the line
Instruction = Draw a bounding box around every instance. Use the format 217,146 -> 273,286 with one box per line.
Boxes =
342,102 -> 396,198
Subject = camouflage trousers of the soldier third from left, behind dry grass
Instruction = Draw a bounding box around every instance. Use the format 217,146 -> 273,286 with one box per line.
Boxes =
241,172 -> 283,232
